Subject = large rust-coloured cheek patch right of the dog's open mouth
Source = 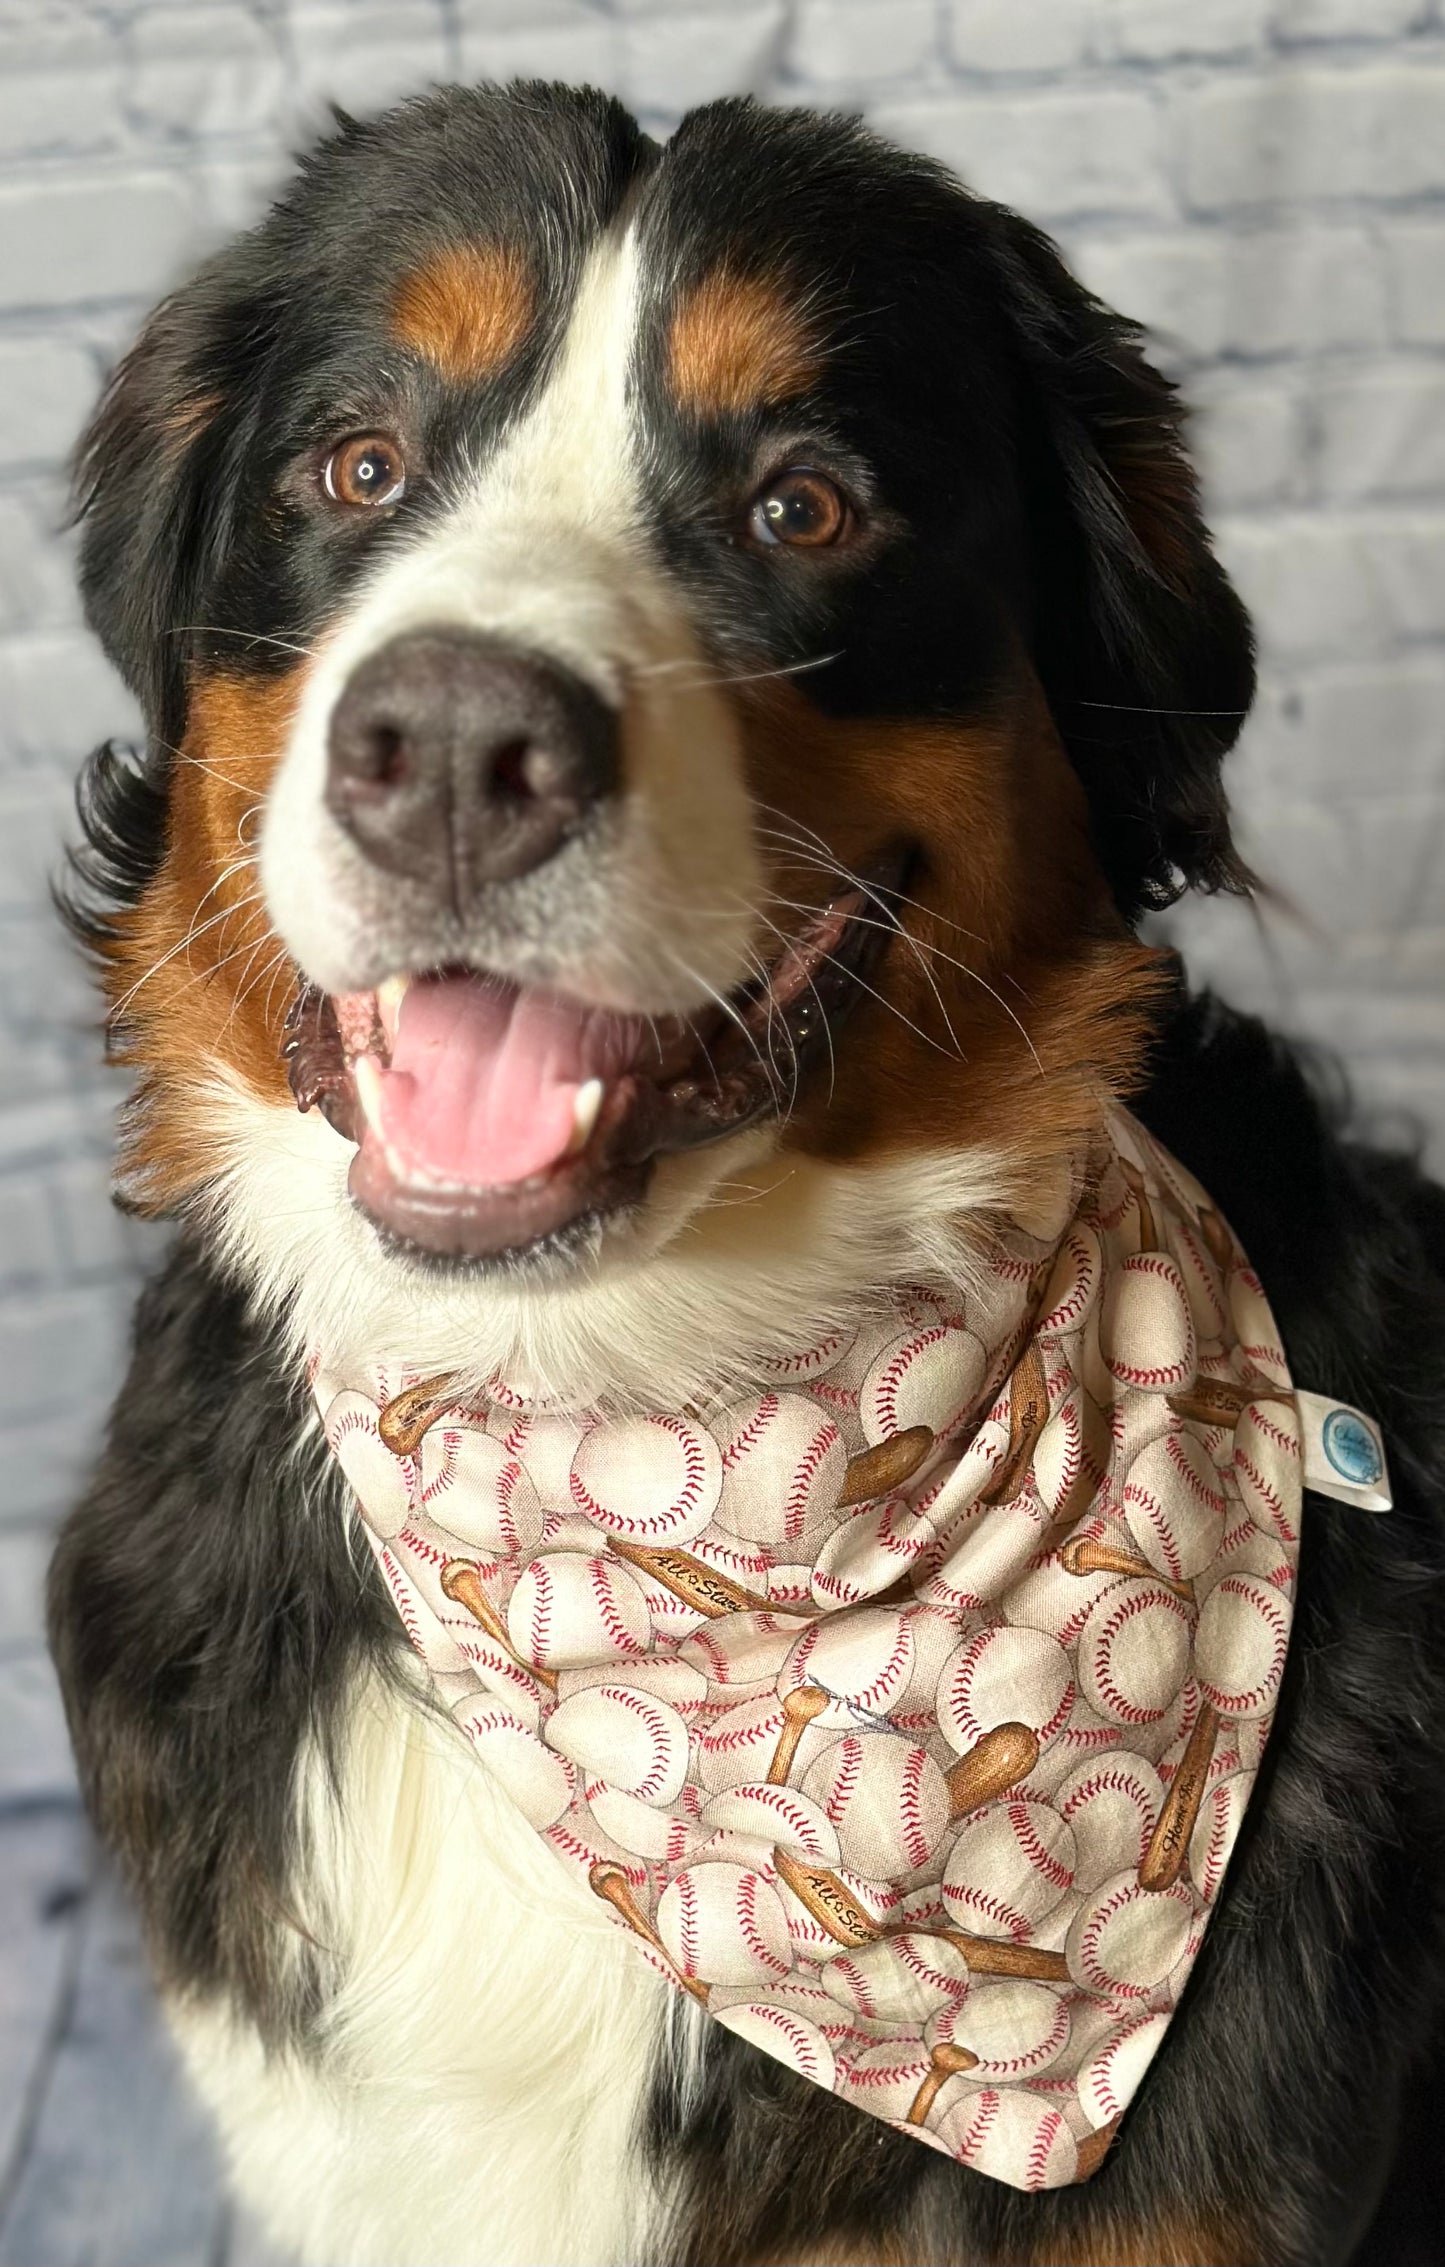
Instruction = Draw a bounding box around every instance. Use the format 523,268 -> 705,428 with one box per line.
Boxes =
749,666 -> 1164,1208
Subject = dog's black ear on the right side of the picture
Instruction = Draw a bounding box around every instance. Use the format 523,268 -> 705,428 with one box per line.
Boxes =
987,206 -> 1254,920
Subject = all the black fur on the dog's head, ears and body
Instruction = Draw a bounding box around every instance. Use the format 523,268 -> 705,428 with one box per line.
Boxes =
52,88 -> 1445,2267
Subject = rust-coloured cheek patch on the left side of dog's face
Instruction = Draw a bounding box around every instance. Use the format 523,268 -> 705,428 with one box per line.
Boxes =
102,666 -> 304,1213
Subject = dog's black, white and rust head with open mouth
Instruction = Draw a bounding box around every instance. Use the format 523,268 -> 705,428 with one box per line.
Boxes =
67,86 -> 1252,1387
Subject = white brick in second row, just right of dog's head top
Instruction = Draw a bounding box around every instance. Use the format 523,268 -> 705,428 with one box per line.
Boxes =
876,91 -> 1171,218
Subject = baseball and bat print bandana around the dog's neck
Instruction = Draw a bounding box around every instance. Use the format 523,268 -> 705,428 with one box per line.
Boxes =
315,1111 -> 1300,2190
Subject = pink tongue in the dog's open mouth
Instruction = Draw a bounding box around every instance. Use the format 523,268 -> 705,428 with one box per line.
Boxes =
381,977 -> 640,1188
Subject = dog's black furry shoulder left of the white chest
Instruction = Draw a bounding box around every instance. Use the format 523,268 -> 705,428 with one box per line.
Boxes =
50,1240 -> 395,2031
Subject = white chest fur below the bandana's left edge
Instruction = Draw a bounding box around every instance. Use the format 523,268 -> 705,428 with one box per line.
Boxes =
172,1680 -> 689,2267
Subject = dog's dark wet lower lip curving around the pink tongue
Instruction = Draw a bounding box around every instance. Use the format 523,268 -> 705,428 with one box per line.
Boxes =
286,852 -> 905,1260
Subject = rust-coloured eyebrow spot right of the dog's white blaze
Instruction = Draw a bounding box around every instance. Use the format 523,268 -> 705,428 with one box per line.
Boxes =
667,265 -> 821,417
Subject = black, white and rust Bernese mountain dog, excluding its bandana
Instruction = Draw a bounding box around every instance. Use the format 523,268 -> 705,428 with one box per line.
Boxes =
50,84 -> 1445,2267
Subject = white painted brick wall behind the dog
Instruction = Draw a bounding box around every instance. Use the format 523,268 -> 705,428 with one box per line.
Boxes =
0,0 -> 1445,1550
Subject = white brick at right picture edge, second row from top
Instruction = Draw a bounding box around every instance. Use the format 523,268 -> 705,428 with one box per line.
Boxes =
1173,61 -> 1445,211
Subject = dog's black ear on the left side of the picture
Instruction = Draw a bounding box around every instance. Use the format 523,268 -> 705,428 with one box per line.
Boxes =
75,256 -> 265,748
